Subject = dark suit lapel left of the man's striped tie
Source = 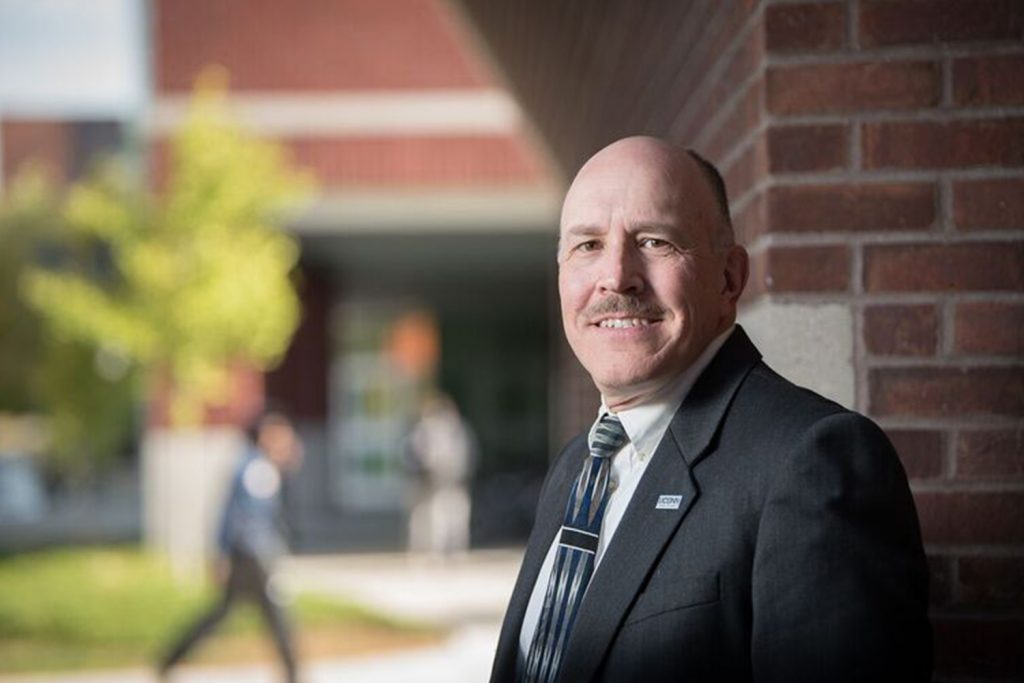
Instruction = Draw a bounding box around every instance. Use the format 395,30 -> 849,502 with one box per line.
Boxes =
490,437 -> 587,681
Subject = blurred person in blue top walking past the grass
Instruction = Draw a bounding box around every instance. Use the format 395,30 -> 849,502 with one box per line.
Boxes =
159,410 -> 302,683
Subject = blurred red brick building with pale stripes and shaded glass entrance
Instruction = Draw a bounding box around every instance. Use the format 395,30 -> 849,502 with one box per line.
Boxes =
148,0 -> 560,550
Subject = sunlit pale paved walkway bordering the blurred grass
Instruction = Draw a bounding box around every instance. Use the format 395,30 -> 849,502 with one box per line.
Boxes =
0,551 -> 521,683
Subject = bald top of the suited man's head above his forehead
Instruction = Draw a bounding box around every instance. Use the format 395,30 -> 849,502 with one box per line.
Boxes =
562,135 -> 735,252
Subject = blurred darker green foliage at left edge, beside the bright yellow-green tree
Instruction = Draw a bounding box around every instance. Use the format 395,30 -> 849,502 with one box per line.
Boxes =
0,167 -> 135,477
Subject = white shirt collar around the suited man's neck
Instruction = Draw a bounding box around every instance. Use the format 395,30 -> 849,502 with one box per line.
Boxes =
590,325 -> 736,461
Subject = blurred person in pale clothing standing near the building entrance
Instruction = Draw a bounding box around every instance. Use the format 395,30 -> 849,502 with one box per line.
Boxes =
409,393 -> 476,557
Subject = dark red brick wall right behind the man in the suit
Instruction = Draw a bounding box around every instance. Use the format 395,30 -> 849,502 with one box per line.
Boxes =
674,0 -> 1024,680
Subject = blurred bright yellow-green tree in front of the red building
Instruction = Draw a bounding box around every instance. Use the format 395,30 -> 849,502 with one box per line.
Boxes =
23,72 -> 308,425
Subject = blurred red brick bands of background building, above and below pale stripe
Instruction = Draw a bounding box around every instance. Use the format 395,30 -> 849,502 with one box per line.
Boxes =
150,0 -> 548,191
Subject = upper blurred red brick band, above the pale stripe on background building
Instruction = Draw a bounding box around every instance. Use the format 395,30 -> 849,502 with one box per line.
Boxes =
153,0 -> 486,93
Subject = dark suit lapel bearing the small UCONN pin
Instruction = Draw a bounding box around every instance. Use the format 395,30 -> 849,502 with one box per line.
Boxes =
557,326 -> 760,681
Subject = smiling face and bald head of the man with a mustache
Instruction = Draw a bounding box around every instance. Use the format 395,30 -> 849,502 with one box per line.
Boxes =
558,140 -> 745,408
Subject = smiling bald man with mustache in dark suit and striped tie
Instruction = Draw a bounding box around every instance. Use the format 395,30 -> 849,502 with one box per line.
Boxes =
492,137 -> 931,683
